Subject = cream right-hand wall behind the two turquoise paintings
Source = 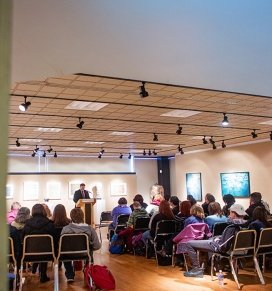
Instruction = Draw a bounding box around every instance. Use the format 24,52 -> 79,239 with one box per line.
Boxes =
175,142 -> 272,208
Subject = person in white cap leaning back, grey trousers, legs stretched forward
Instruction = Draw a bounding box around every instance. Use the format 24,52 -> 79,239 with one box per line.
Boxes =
184,204 -> 246,277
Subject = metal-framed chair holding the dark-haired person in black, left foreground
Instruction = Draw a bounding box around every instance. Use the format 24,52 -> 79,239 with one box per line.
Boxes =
19,234 -> 59,291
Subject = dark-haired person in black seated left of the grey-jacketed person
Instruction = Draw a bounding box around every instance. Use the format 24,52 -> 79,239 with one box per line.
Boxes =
22,204 -> 55,283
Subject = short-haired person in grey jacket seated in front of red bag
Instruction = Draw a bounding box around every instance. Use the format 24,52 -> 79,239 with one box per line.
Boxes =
61,208 -> 101,282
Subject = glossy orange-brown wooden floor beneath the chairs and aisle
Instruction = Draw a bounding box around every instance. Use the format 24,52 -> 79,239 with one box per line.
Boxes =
20,230 -> 272,291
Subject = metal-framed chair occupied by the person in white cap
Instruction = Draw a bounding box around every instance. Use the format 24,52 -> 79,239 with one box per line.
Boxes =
211,230 -> 265,289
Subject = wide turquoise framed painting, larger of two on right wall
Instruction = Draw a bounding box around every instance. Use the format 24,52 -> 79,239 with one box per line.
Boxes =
220,172 -> 250,198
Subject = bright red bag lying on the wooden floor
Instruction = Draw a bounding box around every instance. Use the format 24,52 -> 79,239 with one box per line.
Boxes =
84,265 -> 115,290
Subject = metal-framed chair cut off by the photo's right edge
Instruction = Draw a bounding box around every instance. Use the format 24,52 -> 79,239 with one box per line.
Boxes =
256,227 -> 272,273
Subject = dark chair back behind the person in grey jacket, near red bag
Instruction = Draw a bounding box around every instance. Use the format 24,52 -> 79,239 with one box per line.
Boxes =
57,233 -> 92,262
